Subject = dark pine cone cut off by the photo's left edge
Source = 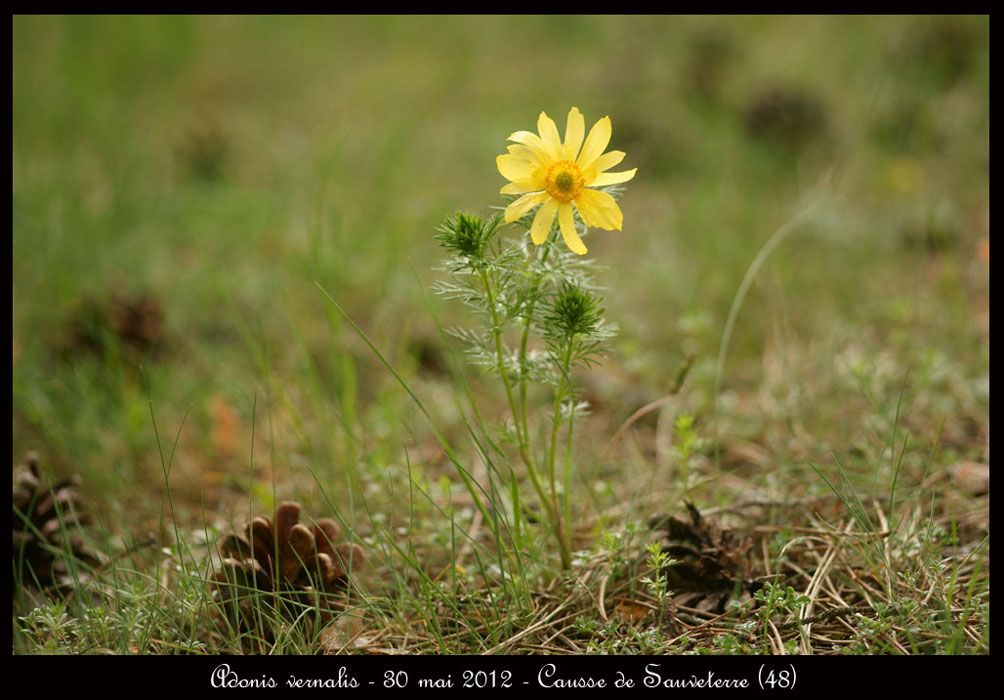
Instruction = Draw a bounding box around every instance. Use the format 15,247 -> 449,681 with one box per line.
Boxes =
11,452 -> 101,590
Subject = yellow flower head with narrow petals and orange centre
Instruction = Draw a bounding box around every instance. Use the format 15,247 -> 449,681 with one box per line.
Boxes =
495,107 -> 638,255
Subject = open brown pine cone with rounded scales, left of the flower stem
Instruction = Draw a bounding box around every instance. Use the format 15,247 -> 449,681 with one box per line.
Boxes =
210,501 -> 363,640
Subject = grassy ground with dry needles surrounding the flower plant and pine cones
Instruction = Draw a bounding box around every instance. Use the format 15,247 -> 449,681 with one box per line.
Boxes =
12,16 -> 989,654
